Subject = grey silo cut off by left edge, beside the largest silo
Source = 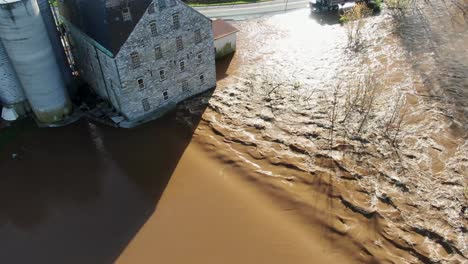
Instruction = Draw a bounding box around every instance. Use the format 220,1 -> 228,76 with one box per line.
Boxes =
0,39 -> 26,116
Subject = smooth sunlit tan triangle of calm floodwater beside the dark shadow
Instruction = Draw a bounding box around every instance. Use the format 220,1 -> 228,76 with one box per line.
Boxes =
117,142 -> 357,263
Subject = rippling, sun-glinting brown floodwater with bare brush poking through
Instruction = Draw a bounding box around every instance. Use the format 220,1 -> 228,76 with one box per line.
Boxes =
176,1 -> 468,263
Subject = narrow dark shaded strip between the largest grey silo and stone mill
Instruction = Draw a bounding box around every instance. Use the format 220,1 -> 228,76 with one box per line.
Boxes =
37,0 -> 73,87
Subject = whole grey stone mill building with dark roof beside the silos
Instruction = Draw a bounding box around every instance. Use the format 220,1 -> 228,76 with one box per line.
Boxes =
59,0 -> 216,127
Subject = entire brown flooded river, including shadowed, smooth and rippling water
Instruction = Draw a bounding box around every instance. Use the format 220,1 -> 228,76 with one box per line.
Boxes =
0,1 -> 468,263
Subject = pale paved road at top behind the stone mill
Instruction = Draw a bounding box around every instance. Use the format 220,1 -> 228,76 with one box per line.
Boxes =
195,0 -> 308,19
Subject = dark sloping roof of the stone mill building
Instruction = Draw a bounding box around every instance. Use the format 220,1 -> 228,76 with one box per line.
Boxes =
58,0 -> 152,55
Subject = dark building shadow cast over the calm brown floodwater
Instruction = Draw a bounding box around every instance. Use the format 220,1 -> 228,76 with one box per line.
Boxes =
0,91 -> 213,264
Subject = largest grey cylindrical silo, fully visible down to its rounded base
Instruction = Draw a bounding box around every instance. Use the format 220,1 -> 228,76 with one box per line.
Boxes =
0,0 -> 71,123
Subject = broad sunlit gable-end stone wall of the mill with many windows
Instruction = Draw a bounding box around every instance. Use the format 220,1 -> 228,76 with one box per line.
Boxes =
116,0 -> 216,119
